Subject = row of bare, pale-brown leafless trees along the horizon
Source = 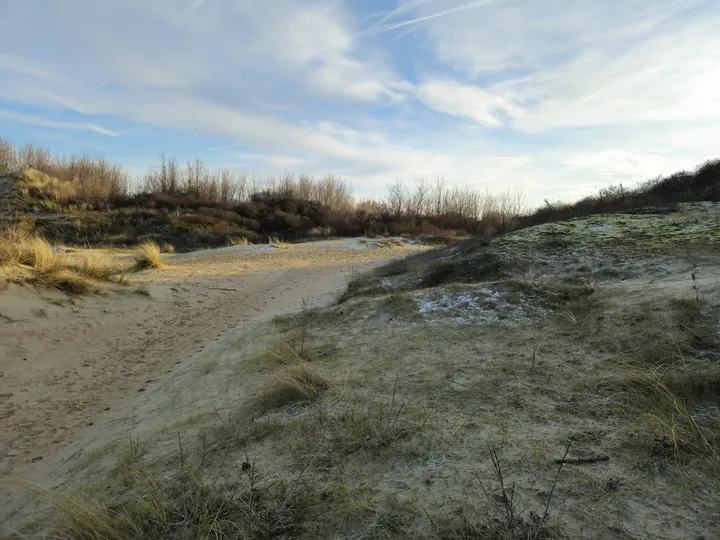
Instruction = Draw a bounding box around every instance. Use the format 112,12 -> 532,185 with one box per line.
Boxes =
0,139 -> 527,221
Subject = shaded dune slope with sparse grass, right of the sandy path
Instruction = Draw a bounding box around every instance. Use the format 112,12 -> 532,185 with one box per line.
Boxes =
9,205 -> 720,540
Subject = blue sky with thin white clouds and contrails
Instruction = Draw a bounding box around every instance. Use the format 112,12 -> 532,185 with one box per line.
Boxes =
0,0 -> 720,203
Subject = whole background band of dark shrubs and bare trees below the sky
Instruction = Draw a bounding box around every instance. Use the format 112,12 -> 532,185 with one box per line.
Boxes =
0,136 -> 720,249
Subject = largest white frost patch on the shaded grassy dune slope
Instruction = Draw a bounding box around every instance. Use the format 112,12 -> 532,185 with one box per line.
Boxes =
413,288 -> 547,324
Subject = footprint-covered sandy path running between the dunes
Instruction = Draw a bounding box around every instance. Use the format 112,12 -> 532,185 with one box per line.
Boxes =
0,244 -> 416,524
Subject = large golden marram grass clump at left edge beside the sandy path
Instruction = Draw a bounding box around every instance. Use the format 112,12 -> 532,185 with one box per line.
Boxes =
0,229 -> 122,294
